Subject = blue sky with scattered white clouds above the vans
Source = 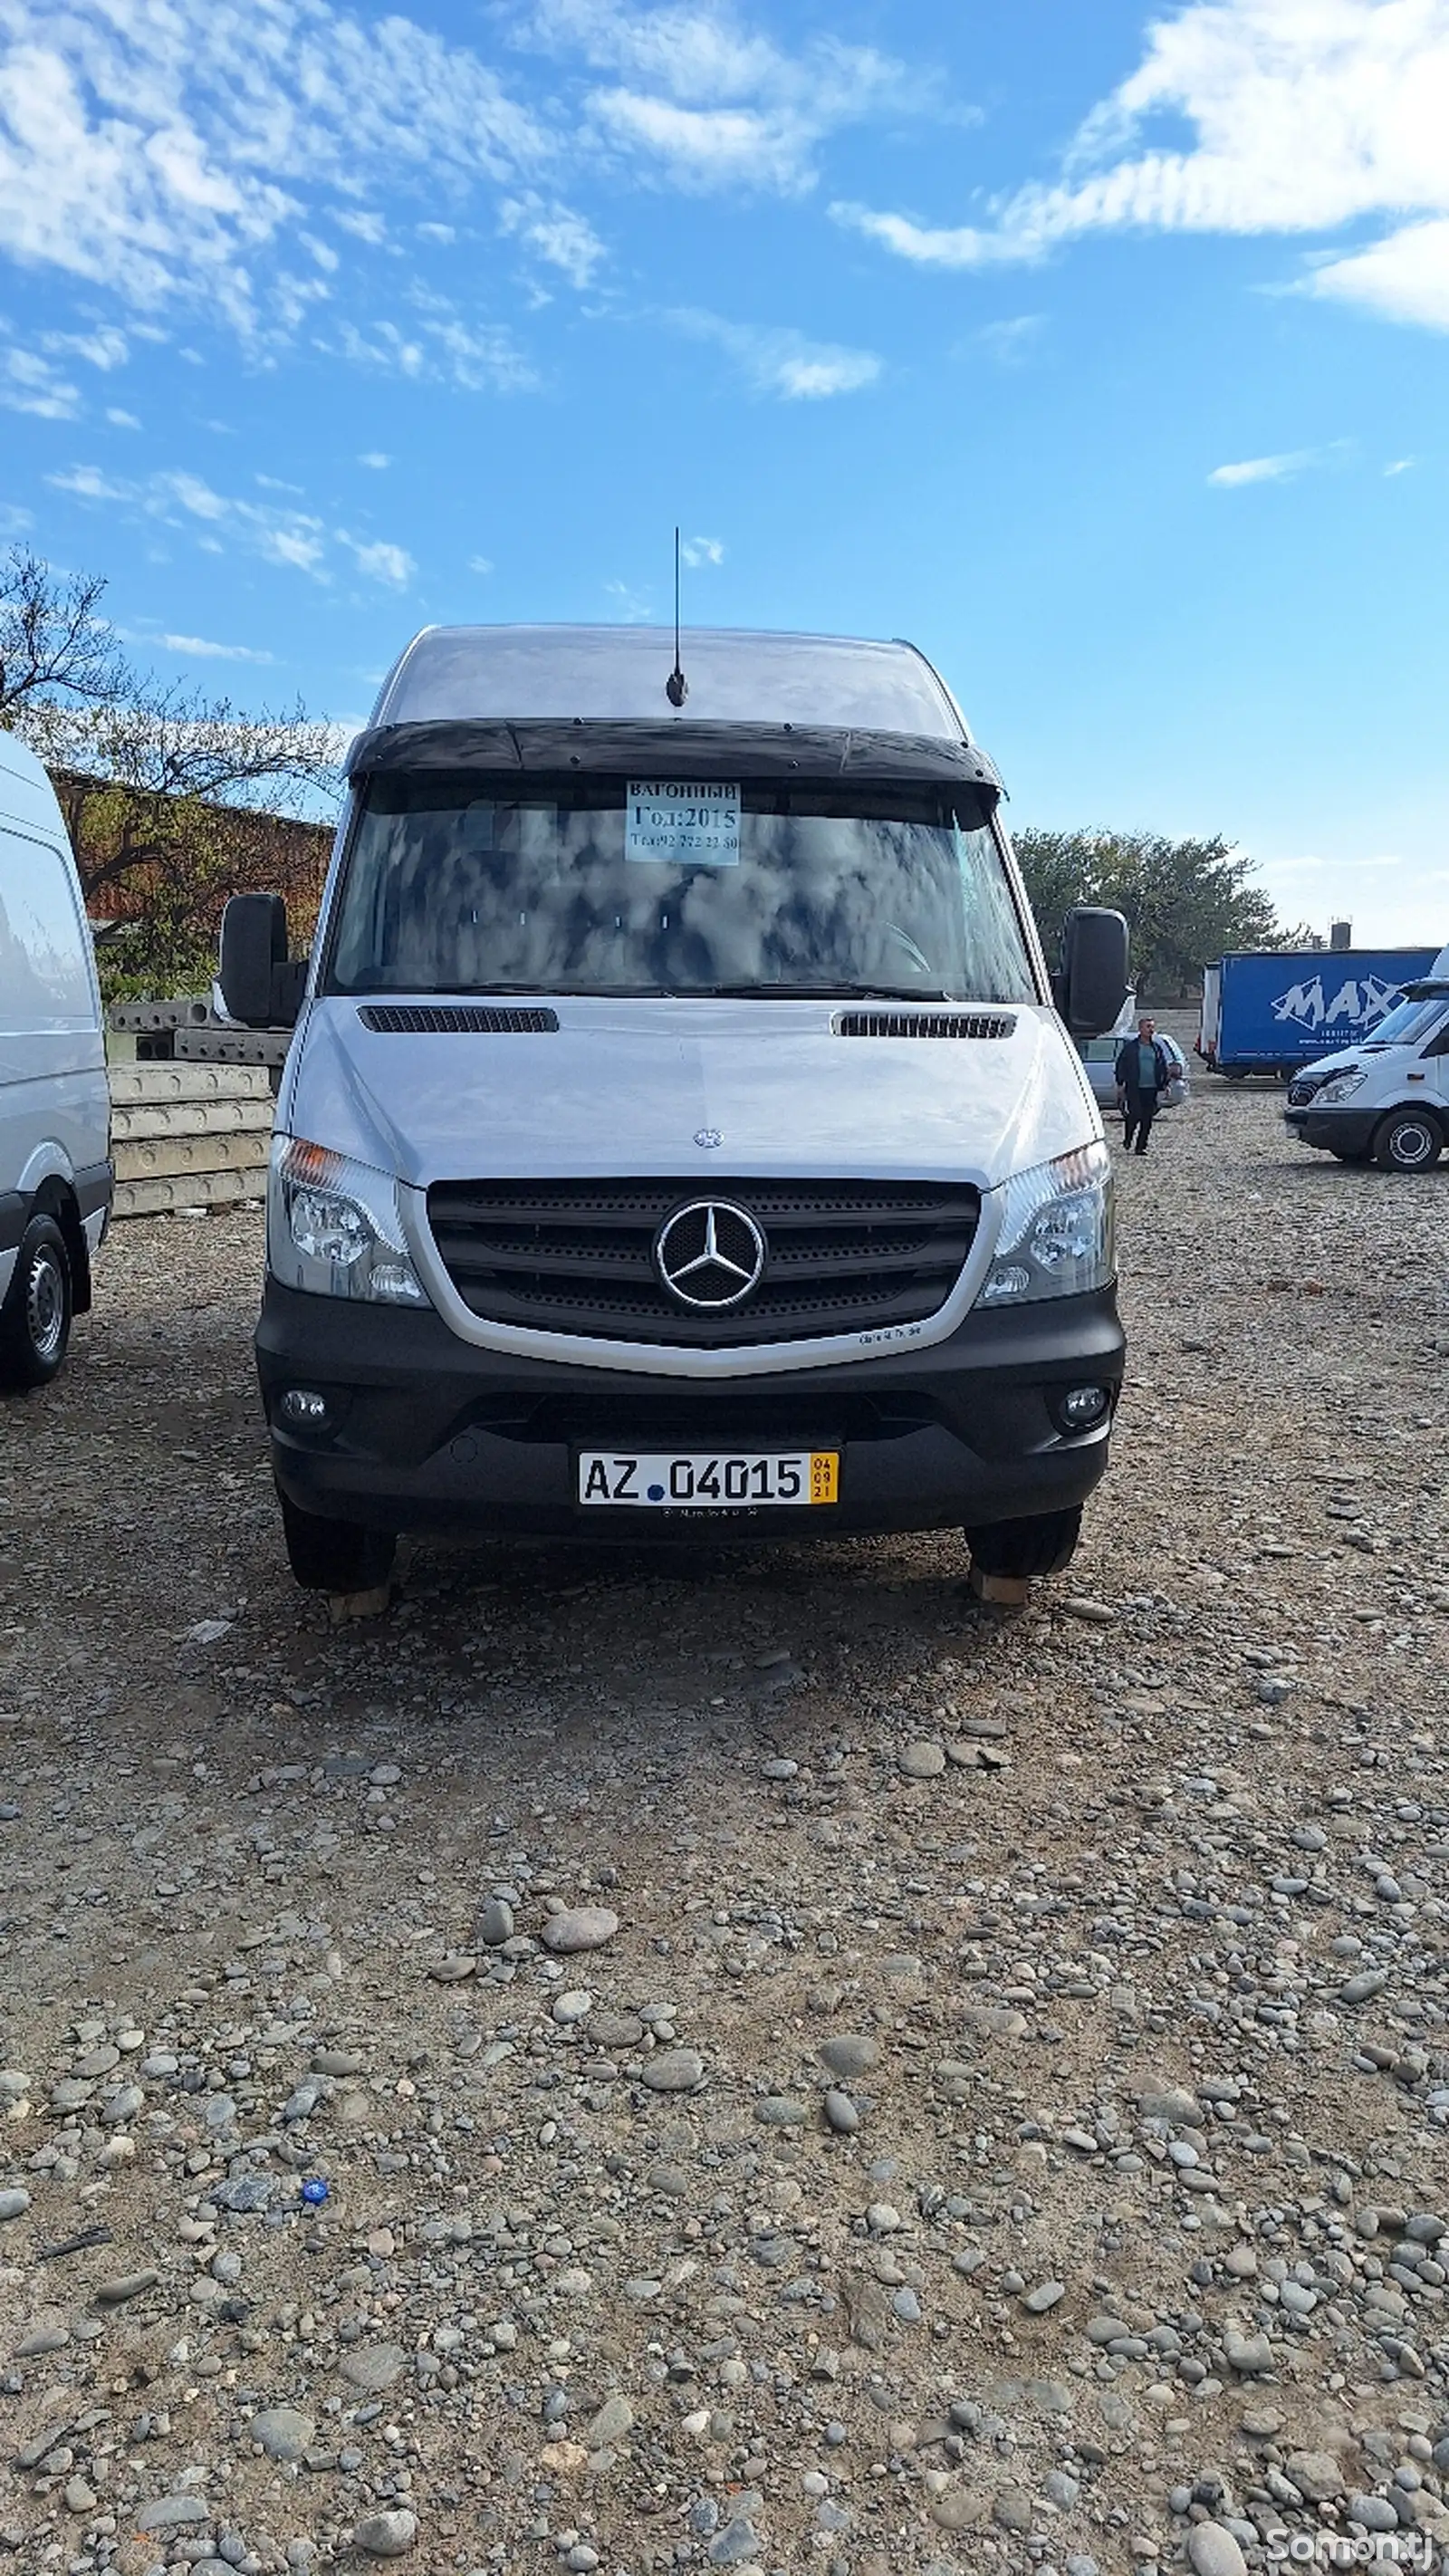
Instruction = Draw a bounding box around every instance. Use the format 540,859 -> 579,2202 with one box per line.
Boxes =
0,0 -> 1449,943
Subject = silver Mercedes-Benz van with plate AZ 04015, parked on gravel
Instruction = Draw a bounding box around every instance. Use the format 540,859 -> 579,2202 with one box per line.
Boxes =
221,626 -> 1128,1590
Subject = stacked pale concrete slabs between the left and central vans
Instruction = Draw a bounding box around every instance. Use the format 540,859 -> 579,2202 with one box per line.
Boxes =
110,1064 -> 273,1216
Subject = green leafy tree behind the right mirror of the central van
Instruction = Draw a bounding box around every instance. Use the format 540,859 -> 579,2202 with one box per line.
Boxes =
1017,832 -> 1284,999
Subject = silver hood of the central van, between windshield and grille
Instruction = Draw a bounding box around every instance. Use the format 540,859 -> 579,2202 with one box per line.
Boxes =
278,995 -> 1101,1190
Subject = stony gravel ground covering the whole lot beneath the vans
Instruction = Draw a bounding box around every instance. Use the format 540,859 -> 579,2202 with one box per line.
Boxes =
0,1084 -> 1449,2576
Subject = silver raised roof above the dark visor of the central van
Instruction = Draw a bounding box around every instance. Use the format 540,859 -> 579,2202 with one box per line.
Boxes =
370,626 -> 970,742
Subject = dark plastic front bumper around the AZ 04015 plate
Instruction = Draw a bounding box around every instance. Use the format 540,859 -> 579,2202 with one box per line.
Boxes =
257,1278 -> 1125,1545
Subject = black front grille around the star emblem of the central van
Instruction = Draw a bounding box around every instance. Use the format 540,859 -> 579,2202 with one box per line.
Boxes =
427,1172 -> 981,1350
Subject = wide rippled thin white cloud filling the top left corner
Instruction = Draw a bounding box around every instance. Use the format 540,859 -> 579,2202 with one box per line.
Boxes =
0,0 -> 556,332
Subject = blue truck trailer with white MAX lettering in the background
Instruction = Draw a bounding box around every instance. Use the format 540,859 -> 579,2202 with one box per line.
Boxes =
1196,948 -> 1436,1081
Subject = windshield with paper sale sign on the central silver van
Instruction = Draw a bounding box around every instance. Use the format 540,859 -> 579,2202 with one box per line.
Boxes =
324,775 -> 1037,1002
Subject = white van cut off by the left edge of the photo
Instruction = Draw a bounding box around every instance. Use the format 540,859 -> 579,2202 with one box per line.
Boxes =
0,732 -> 110,1386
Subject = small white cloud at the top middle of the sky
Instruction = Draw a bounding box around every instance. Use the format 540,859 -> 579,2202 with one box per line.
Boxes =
514,0 -> 921,196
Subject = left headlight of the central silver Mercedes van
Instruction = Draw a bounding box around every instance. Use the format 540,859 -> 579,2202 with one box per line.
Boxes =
268,1136 -> 430,1306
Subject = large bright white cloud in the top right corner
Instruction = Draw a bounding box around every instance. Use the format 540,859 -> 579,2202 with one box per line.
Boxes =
831,0 -> 1449,330
